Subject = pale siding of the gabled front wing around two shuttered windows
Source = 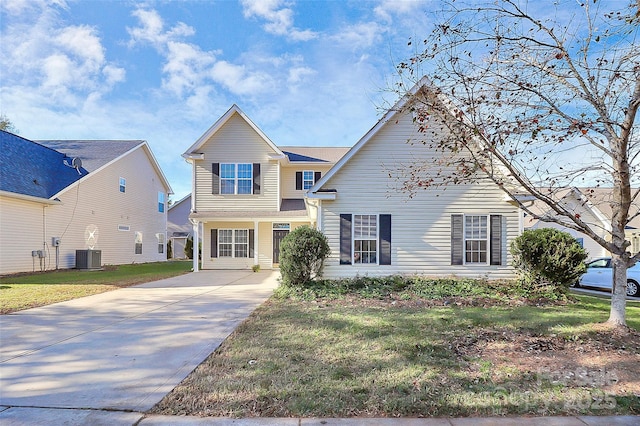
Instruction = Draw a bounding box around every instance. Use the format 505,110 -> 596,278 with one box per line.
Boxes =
321,110 -> 520,278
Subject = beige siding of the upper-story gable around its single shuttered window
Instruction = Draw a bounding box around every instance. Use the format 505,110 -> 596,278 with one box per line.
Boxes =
194,114 -> 279,211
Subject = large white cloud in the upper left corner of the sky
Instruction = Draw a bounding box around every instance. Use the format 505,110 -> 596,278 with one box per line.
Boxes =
0,1 -> 125,105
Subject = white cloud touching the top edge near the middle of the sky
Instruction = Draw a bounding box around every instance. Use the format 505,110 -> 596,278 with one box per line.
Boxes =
240,0 -> 318,41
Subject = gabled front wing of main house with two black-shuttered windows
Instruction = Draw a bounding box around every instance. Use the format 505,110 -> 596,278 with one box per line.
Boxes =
305,81 -> 522,279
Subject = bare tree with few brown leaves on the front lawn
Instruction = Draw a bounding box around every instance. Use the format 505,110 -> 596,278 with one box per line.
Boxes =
395,0 -> 640,326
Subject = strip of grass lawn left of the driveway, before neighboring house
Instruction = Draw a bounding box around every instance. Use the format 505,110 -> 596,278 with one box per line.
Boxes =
0,261 -> 192,314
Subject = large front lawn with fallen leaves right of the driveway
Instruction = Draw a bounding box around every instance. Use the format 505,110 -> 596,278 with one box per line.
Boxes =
152,286 -> 640,417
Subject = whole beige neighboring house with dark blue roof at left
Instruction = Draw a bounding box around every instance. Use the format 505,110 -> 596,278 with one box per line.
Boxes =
0,132 -> 172,274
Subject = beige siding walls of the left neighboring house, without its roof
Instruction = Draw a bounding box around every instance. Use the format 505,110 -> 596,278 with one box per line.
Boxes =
2,147 -> 168,271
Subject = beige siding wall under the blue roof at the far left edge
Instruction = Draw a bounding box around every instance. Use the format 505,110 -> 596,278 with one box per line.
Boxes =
0,196 -> 50,274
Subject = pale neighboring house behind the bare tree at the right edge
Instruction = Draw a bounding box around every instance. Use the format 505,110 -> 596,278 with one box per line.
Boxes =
524,187 -> 640,259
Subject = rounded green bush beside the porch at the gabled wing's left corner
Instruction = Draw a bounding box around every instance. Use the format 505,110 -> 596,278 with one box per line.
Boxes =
280,226 -> 331,287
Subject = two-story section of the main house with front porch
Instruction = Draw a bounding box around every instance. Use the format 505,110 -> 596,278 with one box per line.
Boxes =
183,105 -> 348,271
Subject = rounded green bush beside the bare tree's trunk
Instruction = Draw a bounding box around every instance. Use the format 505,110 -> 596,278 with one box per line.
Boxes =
511,228 -> 587,291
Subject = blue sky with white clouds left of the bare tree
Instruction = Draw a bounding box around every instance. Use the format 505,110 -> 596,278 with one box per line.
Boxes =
0,0 -> 431,200
